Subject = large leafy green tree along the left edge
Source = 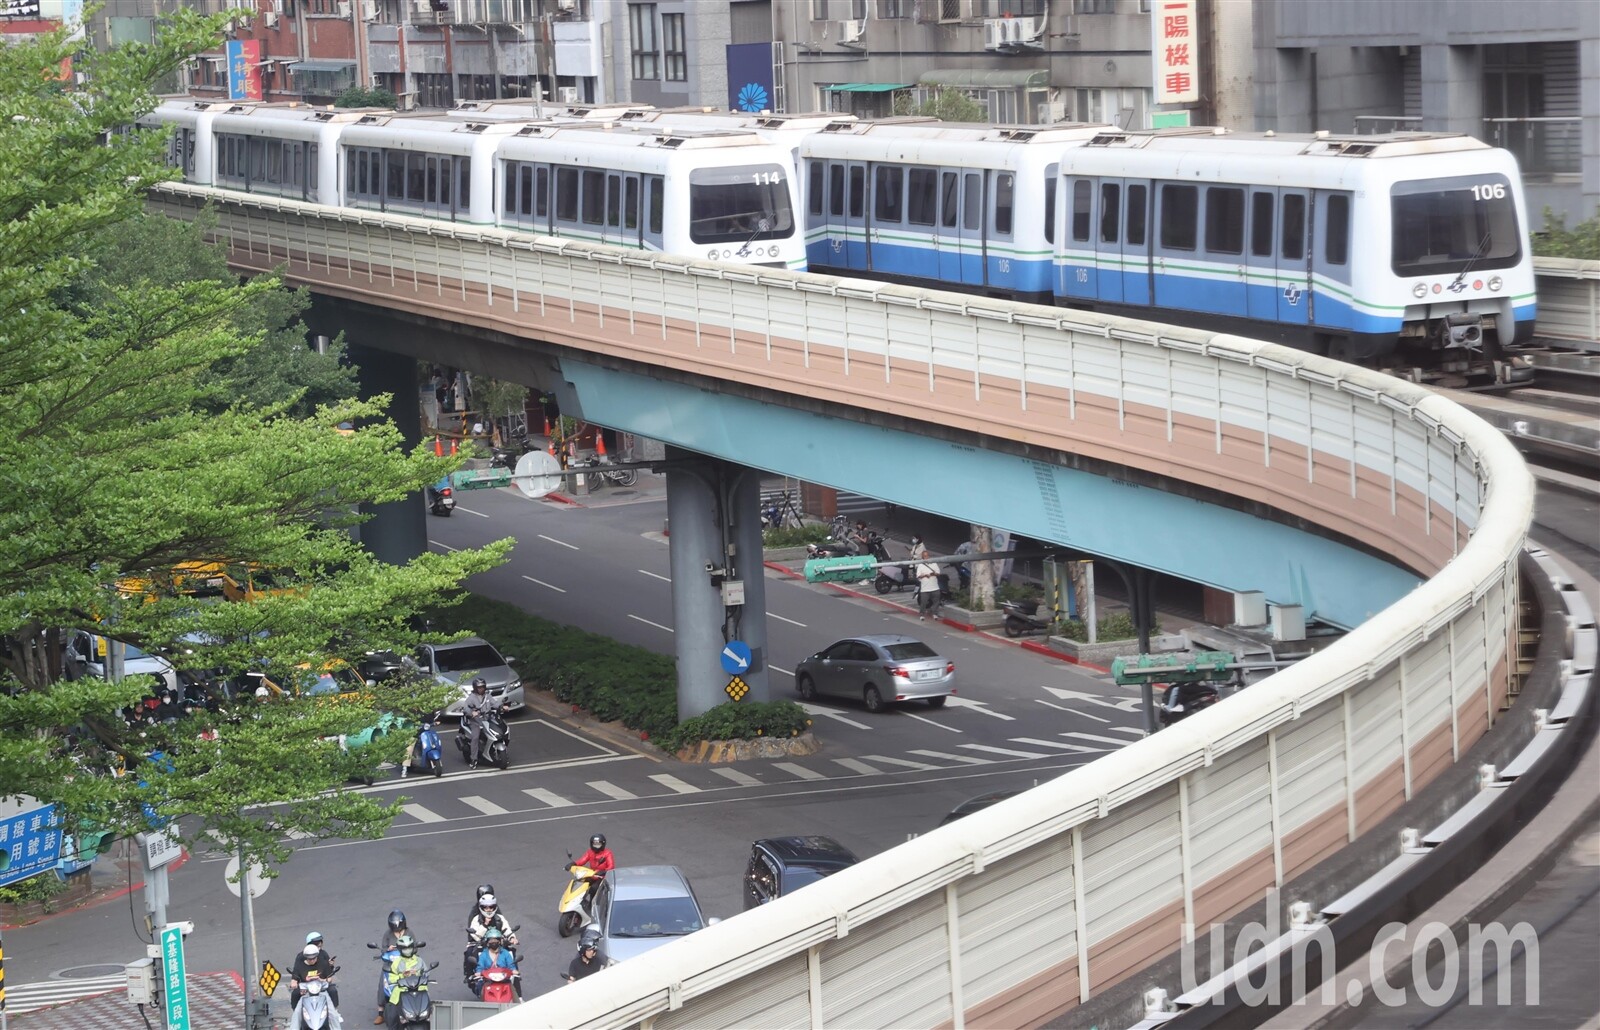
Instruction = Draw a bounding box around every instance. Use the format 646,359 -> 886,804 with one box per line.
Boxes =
0,11 -> 509,865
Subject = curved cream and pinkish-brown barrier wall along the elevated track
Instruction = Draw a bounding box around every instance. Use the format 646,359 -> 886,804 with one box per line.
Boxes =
152,186 -> 1533,1030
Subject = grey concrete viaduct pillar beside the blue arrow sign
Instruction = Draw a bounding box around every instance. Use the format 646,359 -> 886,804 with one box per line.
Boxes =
667,446 -> 771,720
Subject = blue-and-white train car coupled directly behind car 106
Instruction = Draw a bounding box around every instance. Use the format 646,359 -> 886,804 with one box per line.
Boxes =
800,120 -> 1106,304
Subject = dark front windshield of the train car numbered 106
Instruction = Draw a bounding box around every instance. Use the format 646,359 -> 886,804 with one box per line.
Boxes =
1389,174 -> 1522,277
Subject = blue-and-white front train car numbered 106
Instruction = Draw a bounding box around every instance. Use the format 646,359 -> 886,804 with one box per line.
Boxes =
1053,130 -> 1536,382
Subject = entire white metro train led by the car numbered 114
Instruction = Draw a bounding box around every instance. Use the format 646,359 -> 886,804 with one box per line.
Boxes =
141,98 -> 805,272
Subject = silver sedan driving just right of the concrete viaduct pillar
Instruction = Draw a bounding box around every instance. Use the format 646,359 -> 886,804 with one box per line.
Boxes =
795,633 -> 955,712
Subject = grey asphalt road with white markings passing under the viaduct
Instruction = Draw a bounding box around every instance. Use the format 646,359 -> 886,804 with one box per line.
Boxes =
5,491 -> 1139,1017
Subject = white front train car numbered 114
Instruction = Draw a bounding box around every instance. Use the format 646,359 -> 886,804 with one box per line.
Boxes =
499,122 -> 805,272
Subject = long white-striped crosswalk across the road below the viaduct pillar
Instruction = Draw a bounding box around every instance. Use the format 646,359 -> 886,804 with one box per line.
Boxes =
395,726 -> 1144,825
